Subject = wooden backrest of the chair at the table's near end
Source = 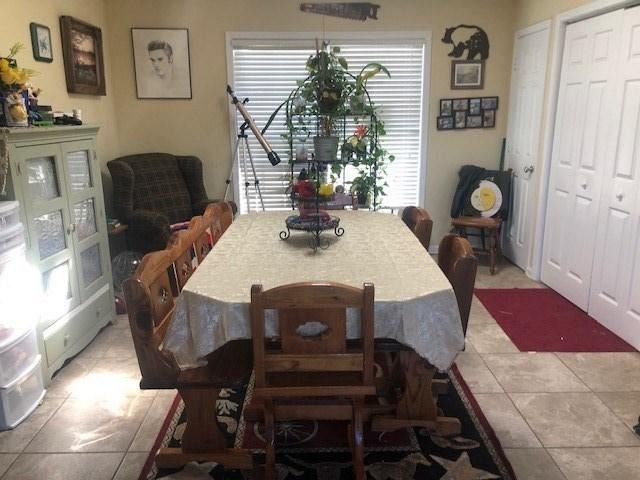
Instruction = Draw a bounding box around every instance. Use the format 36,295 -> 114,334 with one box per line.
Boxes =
251,282 -> 374,397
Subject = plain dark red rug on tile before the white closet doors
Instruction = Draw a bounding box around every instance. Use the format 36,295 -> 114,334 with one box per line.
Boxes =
475,288 -> 636,352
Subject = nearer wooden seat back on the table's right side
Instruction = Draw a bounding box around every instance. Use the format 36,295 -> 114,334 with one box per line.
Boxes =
438,235 -> 478,335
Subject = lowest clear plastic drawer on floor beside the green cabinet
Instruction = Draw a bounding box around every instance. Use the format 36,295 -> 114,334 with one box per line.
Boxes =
0,355 -> 45,430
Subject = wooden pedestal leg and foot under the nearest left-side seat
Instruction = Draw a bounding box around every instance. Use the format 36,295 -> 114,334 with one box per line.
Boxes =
156,388 -> 253,469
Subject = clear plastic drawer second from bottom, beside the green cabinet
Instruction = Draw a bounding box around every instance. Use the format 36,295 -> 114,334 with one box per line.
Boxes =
0,325 -> 38,388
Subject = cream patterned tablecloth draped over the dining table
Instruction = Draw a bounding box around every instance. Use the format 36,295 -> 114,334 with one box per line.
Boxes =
163,211 -> 464,370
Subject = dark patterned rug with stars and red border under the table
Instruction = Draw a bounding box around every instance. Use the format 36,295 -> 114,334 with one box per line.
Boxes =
139,366 -> 515,480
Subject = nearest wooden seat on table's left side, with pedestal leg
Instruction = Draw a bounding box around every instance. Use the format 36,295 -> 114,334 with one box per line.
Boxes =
123,248 -> 253,469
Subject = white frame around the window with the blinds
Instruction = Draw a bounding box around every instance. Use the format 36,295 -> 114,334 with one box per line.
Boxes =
225,31 -> 432,208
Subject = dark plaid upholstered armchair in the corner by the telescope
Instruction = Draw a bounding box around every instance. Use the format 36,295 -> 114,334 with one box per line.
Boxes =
107,153 -> 228,253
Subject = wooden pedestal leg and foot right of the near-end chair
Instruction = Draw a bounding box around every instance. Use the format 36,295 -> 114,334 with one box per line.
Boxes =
371,351 -> 461,435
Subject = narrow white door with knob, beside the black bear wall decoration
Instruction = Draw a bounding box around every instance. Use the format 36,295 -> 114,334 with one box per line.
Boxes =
503,22 -> 549,270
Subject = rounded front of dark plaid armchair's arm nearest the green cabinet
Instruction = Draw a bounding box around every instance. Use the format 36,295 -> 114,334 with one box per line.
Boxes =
128,209 -> 171,254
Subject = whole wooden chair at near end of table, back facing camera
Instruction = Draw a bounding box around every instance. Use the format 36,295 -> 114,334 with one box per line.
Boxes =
251,282 -> 375,480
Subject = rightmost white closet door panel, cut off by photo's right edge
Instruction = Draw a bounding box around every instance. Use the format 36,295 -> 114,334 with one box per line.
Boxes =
589,7 -> 640,348
